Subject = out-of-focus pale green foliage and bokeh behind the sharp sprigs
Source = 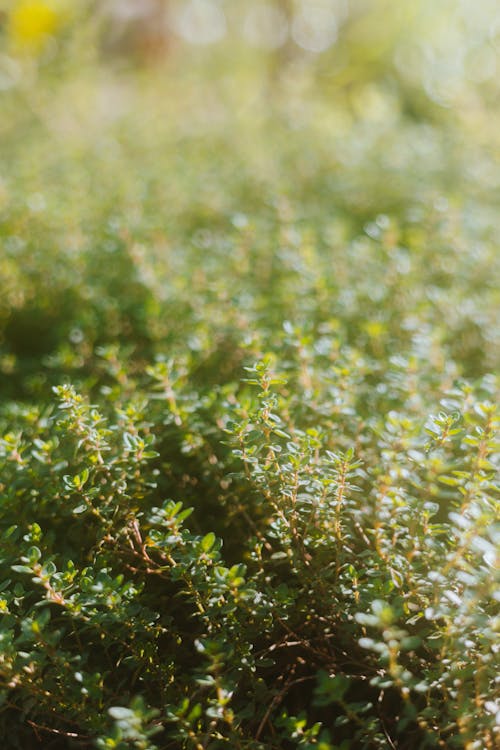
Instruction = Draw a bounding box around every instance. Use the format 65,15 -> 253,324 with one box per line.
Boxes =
0,0 -> 500,395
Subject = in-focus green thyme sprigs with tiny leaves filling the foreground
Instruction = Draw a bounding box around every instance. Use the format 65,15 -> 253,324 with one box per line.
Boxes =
0,356 -> 499,750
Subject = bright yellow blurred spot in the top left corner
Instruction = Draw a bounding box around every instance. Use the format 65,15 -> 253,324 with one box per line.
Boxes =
8,0 -> 63,53
